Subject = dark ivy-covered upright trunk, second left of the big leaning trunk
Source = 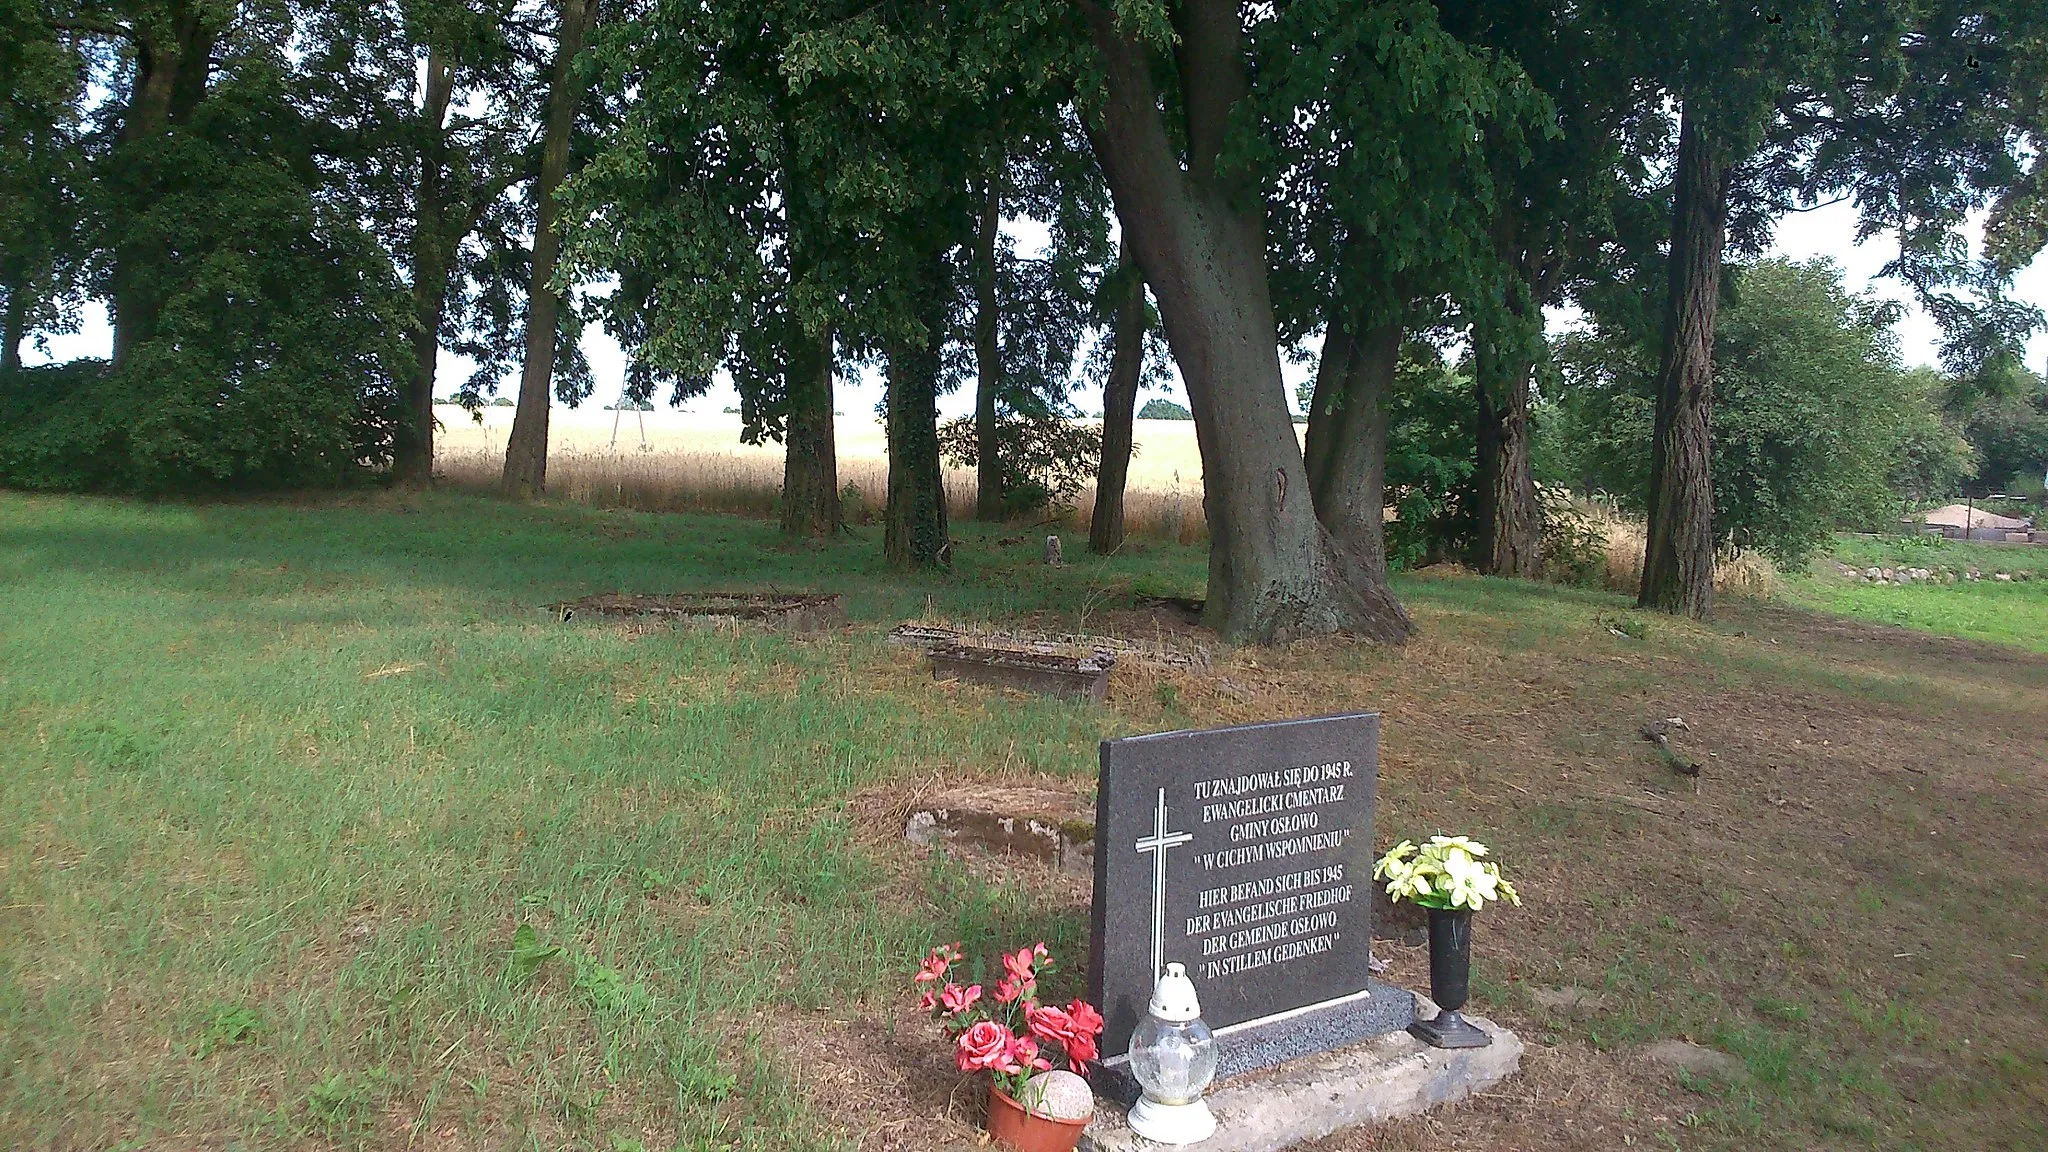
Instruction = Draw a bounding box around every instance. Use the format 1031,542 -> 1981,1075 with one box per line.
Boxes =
883,254 -> 952,568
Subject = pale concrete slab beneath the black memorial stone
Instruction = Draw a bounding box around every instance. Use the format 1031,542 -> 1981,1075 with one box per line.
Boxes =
1081,996 -> 1522,1152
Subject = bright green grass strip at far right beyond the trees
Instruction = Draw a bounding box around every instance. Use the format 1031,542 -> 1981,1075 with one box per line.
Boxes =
1786,537 -> 2048,652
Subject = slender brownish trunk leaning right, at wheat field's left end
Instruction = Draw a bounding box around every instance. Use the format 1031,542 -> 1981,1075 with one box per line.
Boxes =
504,0 -> 598,496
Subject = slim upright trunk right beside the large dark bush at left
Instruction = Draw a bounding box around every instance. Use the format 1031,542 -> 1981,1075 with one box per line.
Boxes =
391,49 -> 455,486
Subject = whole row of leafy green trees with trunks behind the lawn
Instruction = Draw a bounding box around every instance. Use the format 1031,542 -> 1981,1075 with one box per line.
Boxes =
0,0 -> 2048,642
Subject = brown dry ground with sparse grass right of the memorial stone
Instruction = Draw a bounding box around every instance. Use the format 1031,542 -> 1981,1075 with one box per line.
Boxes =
823,586 -> 2048,1152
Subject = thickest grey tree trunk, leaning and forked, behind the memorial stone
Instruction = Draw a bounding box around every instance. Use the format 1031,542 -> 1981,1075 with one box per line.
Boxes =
1085,0 -> 1409,644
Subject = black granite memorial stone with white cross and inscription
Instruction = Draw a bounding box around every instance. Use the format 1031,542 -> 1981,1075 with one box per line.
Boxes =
1090,713 -> 1415,1097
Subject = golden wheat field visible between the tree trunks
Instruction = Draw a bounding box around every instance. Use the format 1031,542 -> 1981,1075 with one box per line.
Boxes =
434,406 -> 1208,543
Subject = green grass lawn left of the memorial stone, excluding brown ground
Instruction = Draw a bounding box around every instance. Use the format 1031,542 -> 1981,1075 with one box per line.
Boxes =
0,494 -> 1200,1148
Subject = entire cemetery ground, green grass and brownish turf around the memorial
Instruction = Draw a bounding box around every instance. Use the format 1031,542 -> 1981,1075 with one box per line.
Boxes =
0,494 -> 2048,1152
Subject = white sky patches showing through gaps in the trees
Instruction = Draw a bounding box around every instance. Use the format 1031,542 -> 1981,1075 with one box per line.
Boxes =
23,203 -> 2048,416
